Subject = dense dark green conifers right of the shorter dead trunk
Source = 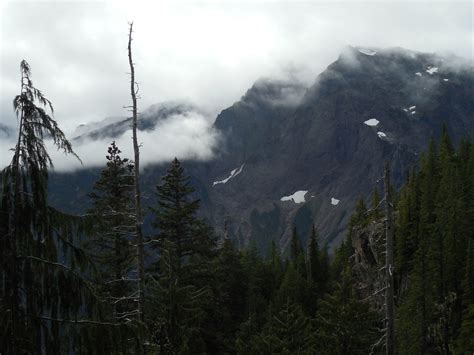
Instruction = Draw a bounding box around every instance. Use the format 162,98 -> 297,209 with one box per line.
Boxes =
396,136 -> 474,354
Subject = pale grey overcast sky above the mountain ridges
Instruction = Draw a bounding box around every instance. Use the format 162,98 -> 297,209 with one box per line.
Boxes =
0,1 -> 474,170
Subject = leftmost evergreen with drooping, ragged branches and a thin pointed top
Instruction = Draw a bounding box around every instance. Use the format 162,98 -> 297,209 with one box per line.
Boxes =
0,60 -> 104,354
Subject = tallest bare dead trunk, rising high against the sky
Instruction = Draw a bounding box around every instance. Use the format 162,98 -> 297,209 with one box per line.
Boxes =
128,22 -> 145,322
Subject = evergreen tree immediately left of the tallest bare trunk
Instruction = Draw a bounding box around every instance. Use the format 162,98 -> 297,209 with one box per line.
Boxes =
87,142 -> 138,352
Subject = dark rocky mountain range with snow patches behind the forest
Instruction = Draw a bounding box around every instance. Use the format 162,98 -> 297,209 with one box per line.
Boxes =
51,47 -> 474,252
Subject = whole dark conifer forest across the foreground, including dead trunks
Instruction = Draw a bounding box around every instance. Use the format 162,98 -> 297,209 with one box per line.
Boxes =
0,24 -> 474,354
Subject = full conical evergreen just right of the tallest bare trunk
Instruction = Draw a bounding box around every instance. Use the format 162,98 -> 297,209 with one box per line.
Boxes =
149,159 -> 215,352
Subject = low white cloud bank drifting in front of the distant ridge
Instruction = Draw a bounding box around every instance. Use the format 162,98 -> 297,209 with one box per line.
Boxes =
0,113 -> 220,172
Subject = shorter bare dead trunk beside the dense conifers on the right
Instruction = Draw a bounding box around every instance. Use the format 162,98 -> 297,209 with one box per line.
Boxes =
384,162 -> 395,355
